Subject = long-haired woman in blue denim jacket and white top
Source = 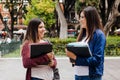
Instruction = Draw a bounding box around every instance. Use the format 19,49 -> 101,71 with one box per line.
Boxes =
66,6 -> 106,80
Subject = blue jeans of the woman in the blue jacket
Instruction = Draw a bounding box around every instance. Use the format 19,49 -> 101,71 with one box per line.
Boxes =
75,75 -> 102,80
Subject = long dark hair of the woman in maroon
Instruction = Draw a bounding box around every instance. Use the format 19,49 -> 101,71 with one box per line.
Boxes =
24,18 -> 43,42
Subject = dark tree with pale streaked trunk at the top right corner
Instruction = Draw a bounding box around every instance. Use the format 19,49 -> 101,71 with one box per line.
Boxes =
99,0 -> 120,36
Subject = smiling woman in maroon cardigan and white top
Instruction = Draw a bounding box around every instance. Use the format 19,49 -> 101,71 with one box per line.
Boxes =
21,18 -> 57,80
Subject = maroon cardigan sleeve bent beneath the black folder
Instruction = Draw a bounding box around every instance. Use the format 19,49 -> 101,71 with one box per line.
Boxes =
21,43 -> 50,68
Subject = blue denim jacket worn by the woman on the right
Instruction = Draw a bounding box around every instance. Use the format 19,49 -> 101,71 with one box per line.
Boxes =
75,29 -> 106,77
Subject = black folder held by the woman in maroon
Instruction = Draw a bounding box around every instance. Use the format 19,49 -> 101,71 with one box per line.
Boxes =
30,42 -> 53,58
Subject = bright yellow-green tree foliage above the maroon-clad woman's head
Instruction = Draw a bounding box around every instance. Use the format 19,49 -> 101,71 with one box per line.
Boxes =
24,0 -> 55,28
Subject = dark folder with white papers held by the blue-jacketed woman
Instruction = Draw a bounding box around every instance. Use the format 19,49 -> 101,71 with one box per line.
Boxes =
66,42 -> 92,57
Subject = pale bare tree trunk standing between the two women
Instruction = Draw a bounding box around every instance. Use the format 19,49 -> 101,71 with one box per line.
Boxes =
56,2 -> 67,39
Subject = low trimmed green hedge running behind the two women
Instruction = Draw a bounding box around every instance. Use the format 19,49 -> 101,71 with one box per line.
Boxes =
0,36 -> 120,57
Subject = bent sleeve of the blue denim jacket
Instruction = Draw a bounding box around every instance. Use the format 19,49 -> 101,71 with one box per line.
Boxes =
75,31 -> 106,66
